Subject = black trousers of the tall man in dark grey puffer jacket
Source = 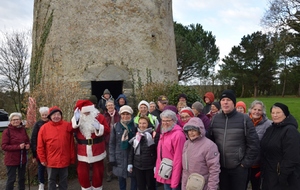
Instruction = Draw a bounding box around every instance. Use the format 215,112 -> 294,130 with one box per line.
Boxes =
219,166 -> 248,190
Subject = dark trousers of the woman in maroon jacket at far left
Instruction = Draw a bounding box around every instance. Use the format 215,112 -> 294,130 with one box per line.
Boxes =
5,164 -> 26,190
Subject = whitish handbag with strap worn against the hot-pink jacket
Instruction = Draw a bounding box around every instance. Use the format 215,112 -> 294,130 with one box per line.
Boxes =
158,141 -> 173,179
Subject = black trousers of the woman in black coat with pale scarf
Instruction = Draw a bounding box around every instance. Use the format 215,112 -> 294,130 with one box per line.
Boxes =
133,167 -> 156,190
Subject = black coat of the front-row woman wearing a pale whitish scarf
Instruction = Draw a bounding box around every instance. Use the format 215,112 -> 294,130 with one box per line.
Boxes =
128,130 -> 159,170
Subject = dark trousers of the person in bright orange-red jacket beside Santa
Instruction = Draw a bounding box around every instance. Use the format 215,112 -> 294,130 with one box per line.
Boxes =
47,167 -> 68,190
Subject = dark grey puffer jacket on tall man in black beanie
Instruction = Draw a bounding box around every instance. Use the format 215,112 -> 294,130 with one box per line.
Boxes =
208,109 -> 259,169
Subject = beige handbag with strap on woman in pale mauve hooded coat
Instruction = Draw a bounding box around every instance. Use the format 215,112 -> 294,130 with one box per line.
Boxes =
184,148 -> 205,190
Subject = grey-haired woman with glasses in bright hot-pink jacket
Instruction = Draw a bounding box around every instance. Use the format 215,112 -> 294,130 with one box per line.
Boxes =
154,110 -> 185,190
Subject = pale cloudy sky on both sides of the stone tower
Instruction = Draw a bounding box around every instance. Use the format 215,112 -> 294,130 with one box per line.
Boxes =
0,0 -> 268,67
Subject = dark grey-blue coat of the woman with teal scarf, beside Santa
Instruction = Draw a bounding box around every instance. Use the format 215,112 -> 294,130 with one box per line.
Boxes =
109,120 -> 136,178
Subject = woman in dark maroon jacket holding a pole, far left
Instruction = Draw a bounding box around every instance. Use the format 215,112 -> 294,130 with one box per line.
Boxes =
1,112 -> 30,190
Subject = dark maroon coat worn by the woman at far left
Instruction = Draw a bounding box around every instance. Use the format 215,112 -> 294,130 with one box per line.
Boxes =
1,124 -> 29,166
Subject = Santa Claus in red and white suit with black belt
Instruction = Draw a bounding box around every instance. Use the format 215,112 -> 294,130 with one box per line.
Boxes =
72,100 -> 110,190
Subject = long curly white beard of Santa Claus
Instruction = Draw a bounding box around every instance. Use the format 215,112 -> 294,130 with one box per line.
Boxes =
79,114 -> 95,139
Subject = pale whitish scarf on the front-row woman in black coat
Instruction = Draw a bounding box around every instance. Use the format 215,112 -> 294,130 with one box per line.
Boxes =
129,128 -> 154,155
